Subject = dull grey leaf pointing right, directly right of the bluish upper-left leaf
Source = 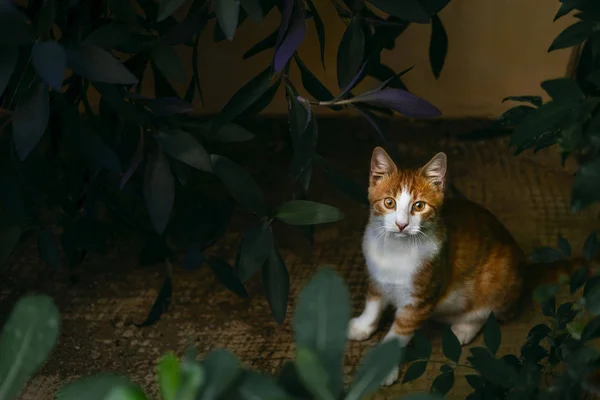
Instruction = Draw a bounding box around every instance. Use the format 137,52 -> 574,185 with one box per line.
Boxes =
65,45 -> 138,85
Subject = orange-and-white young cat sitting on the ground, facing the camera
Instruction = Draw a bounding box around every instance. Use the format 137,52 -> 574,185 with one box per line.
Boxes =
348,147 -> 584,386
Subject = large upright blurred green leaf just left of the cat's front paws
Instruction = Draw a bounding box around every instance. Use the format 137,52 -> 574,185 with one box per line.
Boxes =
293,267 -> 350,397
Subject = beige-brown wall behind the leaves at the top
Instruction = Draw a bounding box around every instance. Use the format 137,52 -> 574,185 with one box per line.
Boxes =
171,0 -> 572,117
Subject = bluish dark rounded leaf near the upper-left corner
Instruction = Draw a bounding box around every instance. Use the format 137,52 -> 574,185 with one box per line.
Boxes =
31,41 -> 67,91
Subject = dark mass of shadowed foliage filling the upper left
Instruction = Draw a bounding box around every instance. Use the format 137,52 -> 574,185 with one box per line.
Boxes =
0,0 -> 449,326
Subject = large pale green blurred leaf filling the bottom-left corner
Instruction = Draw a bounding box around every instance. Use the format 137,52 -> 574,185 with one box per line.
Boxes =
0,295 -> 60,400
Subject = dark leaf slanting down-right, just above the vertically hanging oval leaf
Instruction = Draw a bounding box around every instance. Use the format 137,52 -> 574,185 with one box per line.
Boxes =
157,129 -> 212,172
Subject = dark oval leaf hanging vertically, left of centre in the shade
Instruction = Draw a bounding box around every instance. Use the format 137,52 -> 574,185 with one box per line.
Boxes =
144,149 -> 175,234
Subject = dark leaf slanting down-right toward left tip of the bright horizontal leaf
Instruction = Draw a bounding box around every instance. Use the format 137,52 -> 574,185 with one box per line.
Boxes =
210,154 -> 269,216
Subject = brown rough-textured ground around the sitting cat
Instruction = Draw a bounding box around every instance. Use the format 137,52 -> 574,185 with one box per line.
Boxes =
0,120 -> 598,400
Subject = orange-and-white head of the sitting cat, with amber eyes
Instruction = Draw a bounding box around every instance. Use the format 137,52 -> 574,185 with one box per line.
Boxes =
369,147 -> 446,237
